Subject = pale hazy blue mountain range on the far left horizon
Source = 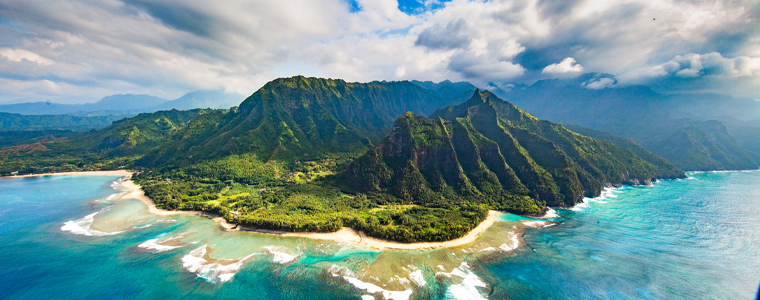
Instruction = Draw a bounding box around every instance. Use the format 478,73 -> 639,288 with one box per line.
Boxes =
0,89 -> 245,117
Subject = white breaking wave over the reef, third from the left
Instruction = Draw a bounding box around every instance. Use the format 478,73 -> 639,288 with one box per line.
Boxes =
182,245 -> 256,282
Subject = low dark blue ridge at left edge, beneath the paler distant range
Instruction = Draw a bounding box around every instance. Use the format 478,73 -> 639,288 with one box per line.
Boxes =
0,113 -> 129,131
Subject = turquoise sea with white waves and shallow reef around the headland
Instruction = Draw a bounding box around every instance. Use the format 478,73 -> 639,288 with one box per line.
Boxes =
0,172 -> 760,299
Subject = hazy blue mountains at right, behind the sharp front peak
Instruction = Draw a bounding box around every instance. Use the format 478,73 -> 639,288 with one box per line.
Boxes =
499,73 -> 760,170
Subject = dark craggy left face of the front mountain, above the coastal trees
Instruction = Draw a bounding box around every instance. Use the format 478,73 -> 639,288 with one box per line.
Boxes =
341,112 -> 544,213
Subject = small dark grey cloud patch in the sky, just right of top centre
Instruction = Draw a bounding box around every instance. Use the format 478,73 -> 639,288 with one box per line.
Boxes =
414,18 -> 472,50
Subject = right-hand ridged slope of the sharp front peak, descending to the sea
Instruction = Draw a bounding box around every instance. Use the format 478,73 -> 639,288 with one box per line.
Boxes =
431,91 -> 684,206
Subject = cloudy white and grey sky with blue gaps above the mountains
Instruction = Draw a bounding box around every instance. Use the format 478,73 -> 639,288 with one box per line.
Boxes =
0,0 -> 760,103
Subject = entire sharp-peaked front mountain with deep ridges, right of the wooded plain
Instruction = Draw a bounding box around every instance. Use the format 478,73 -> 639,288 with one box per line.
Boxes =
345,91 -> 684,212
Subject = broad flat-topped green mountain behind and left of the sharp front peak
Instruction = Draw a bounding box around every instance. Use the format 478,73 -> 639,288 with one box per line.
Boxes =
141,76 -> 458,171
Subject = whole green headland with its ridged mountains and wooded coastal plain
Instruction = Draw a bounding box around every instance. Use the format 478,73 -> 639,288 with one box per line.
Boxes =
0,76 -> 683,242
